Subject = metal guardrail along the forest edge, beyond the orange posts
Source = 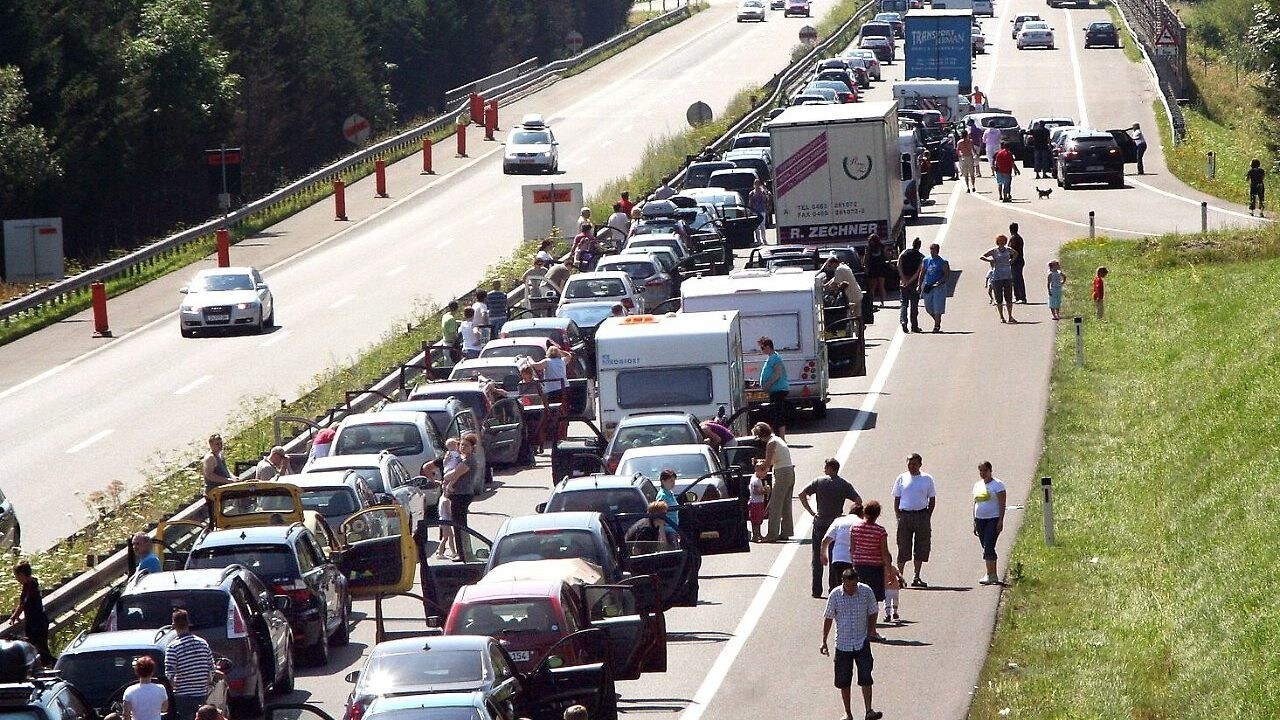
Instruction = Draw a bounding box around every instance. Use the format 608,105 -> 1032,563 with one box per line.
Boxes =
0,0 -> 689,324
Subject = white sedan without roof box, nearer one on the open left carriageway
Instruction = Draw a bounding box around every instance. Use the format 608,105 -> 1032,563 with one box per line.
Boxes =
178,268 -> 275,337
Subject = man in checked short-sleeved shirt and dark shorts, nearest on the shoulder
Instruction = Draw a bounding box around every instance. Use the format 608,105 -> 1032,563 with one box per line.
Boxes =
818,569 -> 884,720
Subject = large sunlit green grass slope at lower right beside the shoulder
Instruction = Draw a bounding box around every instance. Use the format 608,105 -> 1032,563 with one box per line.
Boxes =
970,221 -> 1280,720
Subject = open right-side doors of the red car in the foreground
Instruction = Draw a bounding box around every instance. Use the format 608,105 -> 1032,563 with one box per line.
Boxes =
577,578 -> 667,680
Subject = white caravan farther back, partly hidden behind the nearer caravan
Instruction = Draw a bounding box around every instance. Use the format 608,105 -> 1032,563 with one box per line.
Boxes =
680,268 -> 867,418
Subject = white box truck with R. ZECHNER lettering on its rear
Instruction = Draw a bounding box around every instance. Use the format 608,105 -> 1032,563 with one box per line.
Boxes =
768,101 -> 906,252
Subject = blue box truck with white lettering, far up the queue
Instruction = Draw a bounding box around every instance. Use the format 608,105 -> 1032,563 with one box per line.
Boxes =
902,9 -> 973,92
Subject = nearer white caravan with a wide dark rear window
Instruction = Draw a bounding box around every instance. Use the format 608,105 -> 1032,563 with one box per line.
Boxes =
595,311 -> 748,437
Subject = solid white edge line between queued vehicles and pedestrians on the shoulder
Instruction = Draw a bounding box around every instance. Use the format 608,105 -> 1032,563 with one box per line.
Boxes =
680,179 -> 960,720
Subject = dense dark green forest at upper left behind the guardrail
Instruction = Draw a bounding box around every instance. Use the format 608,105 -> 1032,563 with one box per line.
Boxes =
0,0 -> 631,259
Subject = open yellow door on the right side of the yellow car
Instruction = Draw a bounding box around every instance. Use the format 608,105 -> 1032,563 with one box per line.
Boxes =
334,505 -> 417,598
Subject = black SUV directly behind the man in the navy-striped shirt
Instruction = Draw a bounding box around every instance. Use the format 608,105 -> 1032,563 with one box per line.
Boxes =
90,565 -> 293,715
